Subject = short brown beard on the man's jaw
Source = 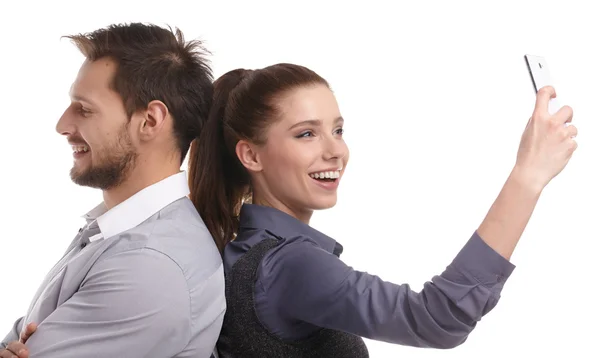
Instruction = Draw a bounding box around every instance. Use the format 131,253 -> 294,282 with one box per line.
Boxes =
71,127 -> 137,190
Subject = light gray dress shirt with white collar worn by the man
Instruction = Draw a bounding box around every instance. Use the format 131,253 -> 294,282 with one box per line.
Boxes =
2,172 -> 225,358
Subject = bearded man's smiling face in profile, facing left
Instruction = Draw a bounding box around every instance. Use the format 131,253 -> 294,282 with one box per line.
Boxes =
56,58 -> 138,190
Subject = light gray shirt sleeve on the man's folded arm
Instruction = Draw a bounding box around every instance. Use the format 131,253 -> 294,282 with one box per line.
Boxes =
27,249 -> 195,358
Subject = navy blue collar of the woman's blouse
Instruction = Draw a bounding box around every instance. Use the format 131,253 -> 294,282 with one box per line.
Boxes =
240,204 -> 344,256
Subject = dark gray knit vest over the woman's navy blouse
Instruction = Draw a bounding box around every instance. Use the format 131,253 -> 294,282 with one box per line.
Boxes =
217,239 -> 369,358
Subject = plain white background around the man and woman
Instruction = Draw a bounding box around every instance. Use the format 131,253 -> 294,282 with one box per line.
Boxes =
0,0 -> 600,357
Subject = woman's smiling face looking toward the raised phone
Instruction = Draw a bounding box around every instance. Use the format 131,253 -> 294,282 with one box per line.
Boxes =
240,85 -> 349,217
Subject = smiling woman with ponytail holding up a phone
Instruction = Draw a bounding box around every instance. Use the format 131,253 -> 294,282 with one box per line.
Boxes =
189,64 -> 576,358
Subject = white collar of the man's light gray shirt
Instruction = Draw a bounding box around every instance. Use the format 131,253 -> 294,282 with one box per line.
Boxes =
83,171 -> 190,241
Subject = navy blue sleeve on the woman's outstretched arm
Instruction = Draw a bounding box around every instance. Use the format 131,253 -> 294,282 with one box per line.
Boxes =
261,233 -> 514,349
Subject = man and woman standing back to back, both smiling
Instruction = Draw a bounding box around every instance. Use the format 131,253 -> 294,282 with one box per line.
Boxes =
0,23 -> 577,358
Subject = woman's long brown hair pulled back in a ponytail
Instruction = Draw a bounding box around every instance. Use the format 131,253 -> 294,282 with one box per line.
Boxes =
189,63 -> 329,252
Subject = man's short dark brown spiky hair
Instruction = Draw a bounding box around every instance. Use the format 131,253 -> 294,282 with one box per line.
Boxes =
65,23 -> 213,163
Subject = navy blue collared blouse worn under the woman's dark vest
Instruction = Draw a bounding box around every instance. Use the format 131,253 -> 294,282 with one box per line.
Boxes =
224,204 -> 514,348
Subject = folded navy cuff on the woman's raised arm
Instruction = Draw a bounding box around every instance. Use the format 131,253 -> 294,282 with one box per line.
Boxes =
452,232 -> 515,287
